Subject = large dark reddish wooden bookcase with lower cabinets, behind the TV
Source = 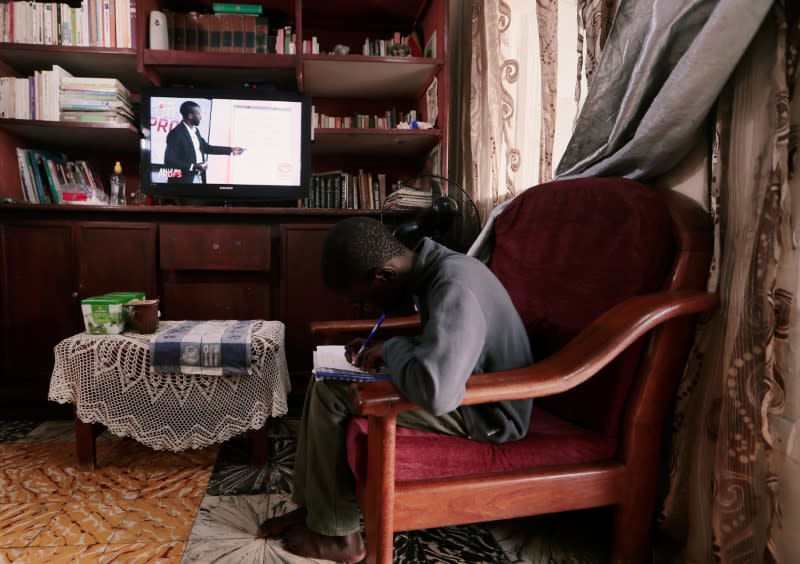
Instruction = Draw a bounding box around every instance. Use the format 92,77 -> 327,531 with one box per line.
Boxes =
0,0 -> 449,417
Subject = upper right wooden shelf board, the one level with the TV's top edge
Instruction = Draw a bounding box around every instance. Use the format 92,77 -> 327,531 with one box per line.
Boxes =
303,55 -> 442,98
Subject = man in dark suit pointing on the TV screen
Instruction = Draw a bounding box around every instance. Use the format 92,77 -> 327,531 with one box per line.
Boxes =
164,101 -> 244,184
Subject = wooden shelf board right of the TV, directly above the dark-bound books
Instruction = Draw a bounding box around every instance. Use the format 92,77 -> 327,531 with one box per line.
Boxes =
311,128 -> 442,157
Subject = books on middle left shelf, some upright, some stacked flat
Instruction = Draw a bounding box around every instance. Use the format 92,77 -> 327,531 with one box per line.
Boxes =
0,65 -> 136,124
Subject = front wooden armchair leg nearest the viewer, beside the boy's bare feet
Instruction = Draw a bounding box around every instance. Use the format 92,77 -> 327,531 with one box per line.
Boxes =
364,416 -> 397,564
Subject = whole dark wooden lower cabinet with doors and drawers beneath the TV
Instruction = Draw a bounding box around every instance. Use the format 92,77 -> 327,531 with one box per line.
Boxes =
0,205 -> 404,419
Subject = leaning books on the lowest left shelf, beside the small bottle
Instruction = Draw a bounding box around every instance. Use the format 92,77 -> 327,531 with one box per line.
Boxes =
17,147 -> 105,204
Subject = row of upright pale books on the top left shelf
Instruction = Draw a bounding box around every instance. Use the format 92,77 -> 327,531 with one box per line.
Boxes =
0,0 -> 136,49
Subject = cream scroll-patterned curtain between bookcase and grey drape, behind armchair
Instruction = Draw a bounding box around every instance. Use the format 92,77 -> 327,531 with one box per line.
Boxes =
460,0 -> 616,225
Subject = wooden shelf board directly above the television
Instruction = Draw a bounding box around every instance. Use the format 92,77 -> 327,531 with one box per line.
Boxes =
144,49 -> 297,90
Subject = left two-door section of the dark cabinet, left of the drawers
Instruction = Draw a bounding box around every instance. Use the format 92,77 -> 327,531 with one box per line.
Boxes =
0,218 -> 156,418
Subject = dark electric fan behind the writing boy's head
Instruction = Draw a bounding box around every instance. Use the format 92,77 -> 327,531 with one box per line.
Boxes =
383,175 -> 481,253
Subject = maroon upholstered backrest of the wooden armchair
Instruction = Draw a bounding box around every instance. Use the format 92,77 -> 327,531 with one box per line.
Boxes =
490,178 -> 677,436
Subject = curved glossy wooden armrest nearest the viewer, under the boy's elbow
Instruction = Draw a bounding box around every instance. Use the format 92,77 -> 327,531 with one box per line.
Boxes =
352,291 -> 719,416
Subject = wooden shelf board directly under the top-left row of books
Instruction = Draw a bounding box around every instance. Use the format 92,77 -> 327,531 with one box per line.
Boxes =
0,43 -> 149,90
